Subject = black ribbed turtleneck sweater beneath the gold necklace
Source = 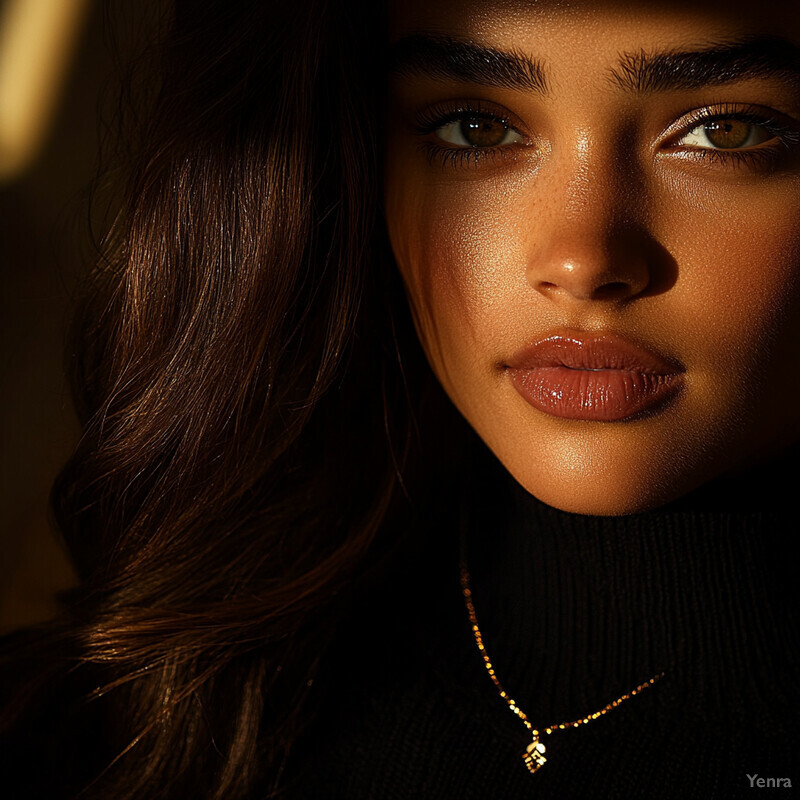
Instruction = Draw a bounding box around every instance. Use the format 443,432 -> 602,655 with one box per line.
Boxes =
289,458 -> 800,800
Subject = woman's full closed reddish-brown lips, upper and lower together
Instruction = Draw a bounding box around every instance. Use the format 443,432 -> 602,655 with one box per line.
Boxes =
502,331 -> 685,422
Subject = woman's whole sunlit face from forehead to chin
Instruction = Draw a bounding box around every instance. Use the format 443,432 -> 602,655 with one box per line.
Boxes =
385,0 -> 800,514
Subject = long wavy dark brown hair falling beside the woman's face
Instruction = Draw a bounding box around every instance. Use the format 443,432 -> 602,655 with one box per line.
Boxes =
0,0 -> 460,798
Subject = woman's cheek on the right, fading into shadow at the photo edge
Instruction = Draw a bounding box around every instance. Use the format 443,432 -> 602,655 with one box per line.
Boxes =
658,182 -> 800,413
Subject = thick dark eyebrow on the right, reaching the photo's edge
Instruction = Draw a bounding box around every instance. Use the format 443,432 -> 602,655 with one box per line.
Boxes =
612,36 -> 800,93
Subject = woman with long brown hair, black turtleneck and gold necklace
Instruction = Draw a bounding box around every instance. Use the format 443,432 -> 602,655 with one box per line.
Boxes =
1,0 -> 800,798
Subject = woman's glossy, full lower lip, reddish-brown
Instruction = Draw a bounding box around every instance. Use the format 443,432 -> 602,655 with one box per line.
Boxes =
508,366 -> 682,422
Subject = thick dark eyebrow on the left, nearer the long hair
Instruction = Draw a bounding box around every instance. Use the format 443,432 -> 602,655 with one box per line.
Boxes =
389,34 -> 547,94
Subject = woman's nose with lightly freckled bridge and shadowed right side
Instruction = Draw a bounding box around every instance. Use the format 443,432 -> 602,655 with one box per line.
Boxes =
527,166 -> 653,302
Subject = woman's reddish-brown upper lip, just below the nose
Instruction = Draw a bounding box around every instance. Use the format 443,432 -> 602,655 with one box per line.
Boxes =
503,331 -> 684,375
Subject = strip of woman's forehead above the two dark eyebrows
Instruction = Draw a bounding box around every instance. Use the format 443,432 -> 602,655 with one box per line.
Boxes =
389,0 -> 800,49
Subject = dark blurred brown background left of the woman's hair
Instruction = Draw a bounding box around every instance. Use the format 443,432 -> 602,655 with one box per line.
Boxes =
0,0 -> 161,631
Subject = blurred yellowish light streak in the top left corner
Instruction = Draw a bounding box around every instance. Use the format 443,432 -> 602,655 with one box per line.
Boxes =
0,0 -> 89,180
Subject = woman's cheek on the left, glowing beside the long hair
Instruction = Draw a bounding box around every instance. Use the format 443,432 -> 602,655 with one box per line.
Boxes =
387,171 -> 528,410
